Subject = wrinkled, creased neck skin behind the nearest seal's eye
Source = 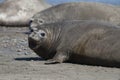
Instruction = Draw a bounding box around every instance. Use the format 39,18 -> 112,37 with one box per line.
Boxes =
46,27 -> 62,53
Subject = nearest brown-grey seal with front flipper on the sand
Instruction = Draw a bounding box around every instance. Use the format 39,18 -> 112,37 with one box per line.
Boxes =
28,20 -> 120,67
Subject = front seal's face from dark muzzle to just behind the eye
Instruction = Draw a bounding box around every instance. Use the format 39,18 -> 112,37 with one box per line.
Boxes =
28,29 -> 52,59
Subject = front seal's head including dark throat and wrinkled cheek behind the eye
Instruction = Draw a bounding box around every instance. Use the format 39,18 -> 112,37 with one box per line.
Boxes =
28,28 -> 59,59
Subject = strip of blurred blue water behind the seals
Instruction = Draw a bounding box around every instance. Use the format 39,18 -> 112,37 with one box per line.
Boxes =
0,0 -> 120,5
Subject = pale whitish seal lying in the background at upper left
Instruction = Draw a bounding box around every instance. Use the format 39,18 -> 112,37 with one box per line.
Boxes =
0,0 -> 51,26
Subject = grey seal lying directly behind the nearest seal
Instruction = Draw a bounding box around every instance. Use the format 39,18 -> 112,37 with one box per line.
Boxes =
30,2 -> 120,29
